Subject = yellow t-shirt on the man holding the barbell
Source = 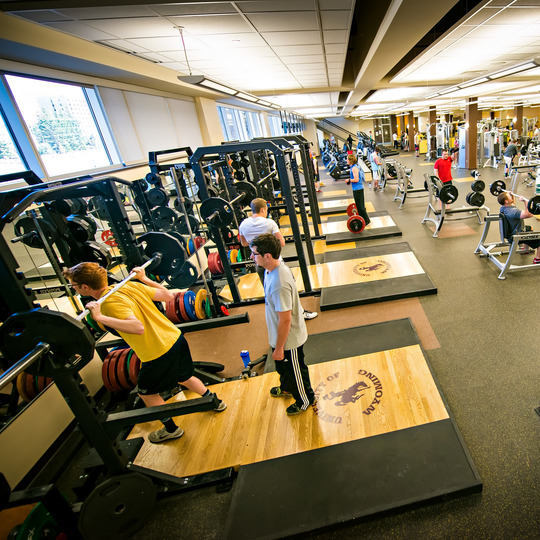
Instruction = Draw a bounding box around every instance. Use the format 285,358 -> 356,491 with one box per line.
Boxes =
101,281 -> 180,362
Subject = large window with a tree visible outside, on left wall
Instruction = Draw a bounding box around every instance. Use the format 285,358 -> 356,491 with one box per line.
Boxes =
6,75 -> 120,177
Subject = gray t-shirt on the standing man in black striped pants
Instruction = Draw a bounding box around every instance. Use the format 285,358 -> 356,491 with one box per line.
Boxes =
264,261 -> 308,350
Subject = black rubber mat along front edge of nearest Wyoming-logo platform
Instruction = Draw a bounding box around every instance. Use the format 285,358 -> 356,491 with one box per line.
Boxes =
224,419 -> 482,540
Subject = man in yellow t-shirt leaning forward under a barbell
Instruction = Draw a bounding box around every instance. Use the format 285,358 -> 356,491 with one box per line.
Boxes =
63,262 -> 227,443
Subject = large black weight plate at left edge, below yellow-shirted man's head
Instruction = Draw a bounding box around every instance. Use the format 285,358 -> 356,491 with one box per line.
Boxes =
0,308 -> 94,377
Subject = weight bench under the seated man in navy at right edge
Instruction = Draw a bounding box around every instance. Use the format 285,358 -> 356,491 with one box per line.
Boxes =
474,214 -> 540,279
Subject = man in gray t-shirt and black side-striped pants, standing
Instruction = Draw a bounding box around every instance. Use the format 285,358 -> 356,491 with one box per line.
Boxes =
250,234 -> 315,416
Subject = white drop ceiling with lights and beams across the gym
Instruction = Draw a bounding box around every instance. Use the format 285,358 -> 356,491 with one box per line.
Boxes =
0,0 -> 540,117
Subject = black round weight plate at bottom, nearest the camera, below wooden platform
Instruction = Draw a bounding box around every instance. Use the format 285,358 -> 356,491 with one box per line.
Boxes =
79,472 -> 156,539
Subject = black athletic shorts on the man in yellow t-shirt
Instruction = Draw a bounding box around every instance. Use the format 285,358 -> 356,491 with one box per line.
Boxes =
137,335 -> 195,395
